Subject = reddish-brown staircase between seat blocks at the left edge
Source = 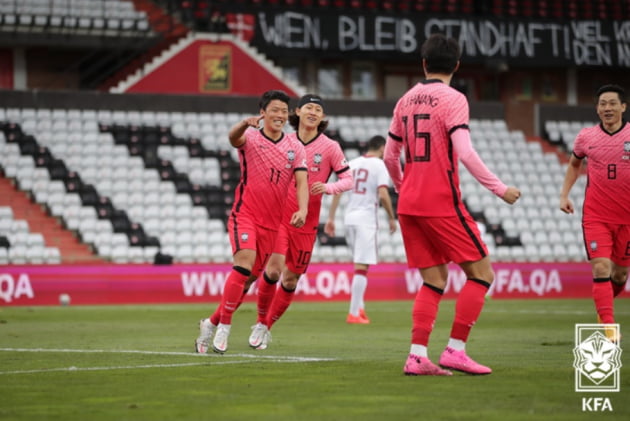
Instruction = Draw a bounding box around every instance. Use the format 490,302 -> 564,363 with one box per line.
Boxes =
0,176 -> 104,264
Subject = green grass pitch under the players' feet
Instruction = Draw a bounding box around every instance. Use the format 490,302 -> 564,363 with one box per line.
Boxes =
0,298 -> 630,421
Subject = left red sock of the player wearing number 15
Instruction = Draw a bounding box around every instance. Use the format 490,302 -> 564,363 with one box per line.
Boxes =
411,284 -> 444,346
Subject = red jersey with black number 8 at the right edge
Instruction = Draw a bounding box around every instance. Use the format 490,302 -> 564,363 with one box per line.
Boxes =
573,122 -> 630,224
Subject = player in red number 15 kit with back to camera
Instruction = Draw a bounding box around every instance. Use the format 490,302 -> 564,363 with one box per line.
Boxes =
384,34 -> 520,376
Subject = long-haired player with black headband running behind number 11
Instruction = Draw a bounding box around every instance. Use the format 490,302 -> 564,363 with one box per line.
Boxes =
249,94 -> 352,349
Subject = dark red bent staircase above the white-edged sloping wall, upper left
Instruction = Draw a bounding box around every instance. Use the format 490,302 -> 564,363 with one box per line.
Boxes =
101,0 -> 189,91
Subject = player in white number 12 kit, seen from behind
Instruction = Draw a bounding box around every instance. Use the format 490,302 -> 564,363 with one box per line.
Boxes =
324,136 -> 398,324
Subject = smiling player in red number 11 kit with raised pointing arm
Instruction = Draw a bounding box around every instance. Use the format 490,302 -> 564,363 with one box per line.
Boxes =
195,90 -> 308,354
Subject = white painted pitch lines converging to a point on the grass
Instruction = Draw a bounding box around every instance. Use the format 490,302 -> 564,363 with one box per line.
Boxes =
0,348 -> 334,375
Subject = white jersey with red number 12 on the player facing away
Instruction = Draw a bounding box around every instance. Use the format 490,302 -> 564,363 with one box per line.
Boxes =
344,156 -> 390,227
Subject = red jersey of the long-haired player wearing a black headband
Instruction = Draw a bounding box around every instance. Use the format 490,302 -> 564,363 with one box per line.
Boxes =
282,132 -> 350,233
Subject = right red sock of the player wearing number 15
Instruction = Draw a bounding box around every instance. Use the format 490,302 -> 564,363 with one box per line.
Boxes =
451,279 -> 490,342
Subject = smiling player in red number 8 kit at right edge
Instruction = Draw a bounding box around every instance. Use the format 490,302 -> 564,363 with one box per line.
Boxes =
560,85 -> 630,340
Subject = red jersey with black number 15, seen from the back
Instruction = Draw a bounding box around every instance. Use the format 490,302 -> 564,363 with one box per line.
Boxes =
385,80 -> 469,216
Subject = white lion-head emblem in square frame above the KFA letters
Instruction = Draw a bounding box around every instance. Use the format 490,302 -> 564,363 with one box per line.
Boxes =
573,324 -> 621,392
